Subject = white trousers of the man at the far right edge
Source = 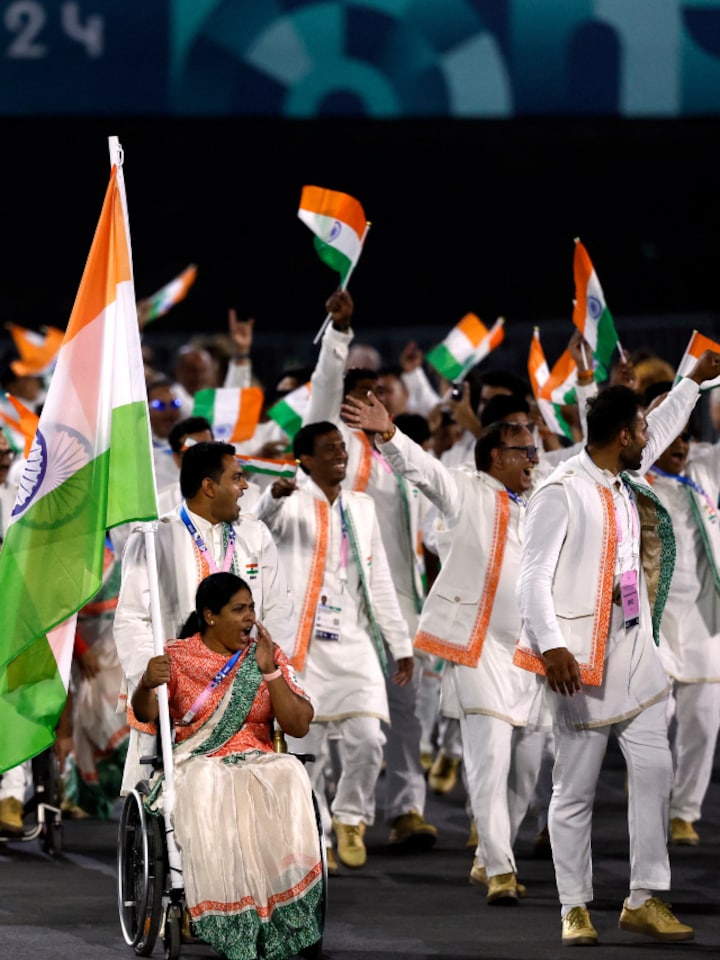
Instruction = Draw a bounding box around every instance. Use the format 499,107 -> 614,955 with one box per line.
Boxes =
670,682 -> 720,823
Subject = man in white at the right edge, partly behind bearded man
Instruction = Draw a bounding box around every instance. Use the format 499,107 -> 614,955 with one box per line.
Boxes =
646,383 -> 720,846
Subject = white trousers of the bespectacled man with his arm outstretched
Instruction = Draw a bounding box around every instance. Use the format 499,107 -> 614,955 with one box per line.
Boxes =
460,713 -> 542,877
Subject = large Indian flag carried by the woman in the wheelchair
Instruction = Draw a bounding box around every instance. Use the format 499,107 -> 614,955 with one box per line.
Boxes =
0,144 -> 157,770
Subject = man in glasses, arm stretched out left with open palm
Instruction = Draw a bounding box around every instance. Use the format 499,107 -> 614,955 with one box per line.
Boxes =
342,393 -> 540,905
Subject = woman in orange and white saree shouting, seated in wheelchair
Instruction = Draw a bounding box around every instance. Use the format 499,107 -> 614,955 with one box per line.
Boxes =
133,573 -> 322,960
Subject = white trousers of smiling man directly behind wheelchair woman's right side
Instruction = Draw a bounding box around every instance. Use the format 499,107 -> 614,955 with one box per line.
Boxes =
286,717 -> 385,846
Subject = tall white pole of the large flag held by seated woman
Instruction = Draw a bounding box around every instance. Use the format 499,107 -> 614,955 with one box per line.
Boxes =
108,137 -> 183,890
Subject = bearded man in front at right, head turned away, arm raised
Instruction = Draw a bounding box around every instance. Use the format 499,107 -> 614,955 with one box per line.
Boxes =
515,351 -> 720,945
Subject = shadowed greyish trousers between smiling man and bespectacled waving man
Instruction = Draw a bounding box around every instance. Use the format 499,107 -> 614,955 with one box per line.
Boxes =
383,653 -> 427,821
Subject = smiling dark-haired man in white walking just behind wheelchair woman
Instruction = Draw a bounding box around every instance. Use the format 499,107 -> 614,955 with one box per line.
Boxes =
257,421 -> 413,871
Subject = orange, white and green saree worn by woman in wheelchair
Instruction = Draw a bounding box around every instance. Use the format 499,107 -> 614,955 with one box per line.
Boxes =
166,636 -> 323,960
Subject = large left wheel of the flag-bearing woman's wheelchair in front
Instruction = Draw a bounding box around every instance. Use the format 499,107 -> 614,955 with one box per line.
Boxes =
118,783 -> 166,957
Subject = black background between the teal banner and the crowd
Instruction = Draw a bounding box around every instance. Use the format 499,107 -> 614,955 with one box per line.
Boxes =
0,117 -> 720,378
